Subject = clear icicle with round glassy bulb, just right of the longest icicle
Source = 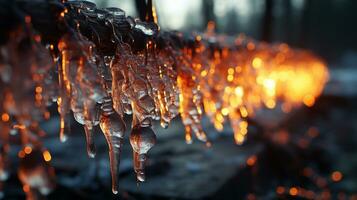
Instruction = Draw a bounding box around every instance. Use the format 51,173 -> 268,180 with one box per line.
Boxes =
130,125 -> 156,182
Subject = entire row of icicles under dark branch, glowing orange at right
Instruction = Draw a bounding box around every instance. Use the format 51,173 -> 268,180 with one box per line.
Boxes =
0,2 -> 328,197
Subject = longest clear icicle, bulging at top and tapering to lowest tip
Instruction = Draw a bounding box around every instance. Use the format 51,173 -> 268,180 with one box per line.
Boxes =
99,97 -> 125,194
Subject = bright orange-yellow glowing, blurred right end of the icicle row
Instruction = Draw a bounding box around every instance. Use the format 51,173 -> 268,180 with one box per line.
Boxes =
178,31 -> 328,144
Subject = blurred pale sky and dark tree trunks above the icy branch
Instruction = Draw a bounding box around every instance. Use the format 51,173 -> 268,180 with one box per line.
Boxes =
92,0 -> 357,63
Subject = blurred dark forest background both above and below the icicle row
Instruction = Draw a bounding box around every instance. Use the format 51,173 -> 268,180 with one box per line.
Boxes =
5,0 -> 357,200
